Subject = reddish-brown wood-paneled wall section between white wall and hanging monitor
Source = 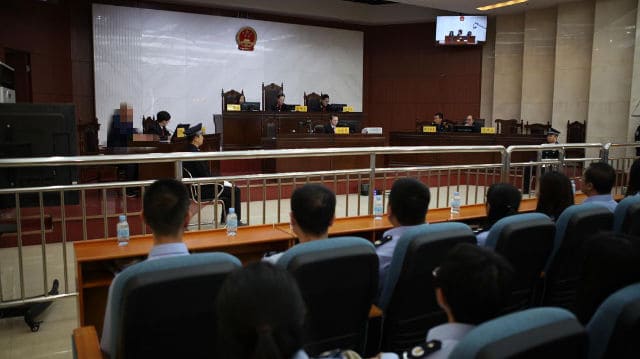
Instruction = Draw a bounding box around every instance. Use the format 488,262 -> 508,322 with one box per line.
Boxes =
364,23 -> 482,131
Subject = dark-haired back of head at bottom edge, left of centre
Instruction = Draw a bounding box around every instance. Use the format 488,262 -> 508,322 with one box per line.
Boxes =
216,262 -> 305,359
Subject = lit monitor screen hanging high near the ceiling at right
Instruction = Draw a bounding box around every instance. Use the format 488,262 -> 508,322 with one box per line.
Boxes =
436,15 -> 487,45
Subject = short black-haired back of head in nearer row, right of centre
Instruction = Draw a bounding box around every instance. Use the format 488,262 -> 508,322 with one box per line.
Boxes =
436,243 -> 514,324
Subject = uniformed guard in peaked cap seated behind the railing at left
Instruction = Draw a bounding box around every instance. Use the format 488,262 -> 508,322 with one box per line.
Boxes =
183,124 -> 242,223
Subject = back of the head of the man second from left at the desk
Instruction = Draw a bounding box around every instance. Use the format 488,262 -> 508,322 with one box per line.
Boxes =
291,184 -> 336,236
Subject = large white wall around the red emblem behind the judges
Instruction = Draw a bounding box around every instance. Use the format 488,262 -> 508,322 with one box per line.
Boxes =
93,4 -> 363,144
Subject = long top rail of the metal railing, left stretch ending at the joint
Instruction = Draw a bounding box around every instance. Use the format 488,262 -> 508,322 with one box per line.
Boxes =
0,146 -> 505,168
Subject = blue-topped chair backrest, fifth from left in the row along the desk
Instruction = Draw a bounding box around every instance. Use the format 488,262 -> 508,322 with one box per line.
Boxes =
543,203 -> 613,310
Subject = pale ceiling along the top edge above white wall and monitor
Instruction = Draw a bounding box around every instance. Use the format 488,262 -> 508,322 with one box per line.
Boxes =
149,0 -> 582,25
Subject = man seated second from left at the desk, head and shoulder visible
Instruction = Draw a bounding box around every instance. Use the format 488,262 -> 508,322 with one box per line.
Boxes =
262,184 -> 336,264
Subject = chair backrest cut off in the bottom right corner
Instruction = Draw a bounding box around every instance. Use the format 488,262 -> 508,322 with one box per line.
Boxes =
587,283 -> 640,359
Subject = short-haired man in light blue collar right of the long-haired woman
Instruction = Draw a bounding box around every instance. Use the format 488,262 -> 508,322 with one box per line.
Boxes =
582,162 -> 618,212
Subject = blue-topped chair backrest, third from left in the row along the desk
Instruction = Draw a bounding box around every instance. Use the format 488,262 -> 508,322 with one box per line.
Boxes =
378,222 -> 476,352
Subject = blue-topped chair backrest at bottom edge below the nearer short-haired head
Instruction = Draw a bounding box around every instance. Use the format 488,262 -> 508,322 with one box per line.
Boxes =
449,308 -> 587,359
